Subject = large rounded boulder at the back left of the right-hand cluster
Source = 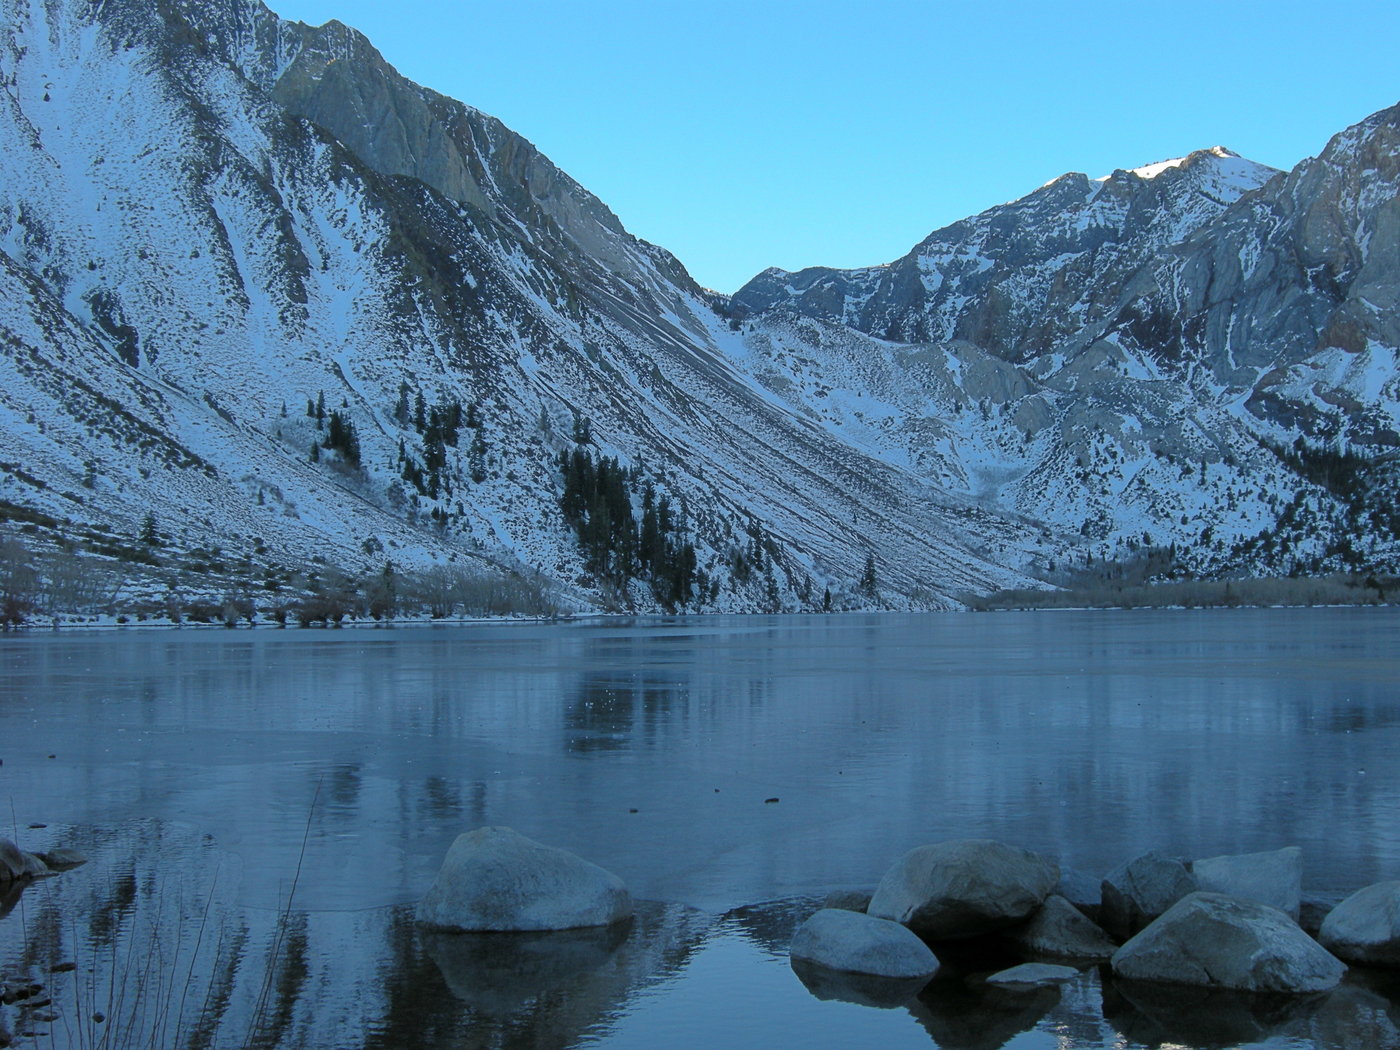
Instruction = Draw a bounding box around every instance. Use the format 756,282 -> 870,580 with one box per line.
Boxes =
867,839 -> 1060,941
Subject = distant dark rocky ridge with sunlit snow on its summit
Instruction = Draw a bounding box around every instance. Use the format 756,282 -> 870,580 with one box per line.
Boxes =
734,147 -> 1278,361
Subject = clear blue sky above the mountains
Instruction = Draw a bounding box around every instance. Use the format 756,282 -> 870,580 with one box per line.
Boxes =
267,0 -> 1400,291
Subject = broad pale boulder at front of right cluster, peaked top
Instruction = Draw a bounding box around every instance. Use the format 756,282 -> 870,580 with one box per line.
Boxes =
1112,892 -> 1347,993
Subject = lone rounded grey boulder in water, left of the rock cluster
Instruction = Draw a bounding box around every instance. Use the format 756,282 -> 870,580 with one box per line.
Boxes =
417,827 -> 631,931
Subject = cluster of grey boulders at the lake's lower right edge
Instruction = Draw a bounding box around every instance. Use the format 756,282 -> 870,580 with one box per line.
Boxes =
791,839 -> 1400,994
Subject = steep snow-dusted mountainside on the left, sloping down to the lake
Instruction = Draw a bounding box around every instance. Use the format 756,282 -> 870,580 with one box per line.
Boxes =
0,0 -> 1039,609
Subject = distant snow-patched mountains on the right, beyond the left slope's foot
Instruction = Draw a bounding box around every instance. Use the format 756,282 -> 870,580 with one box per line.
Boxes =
729,125 -> 1400,585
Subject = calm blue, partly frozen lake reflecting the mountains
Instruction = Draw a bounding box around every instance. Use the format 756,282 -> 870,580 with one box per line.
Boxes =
0,609 -> 1400,1050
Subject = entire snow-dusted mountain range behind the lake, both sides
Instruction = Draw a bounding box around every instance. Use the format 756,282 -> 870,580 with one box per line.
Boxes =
0,0 -> 1397,609
